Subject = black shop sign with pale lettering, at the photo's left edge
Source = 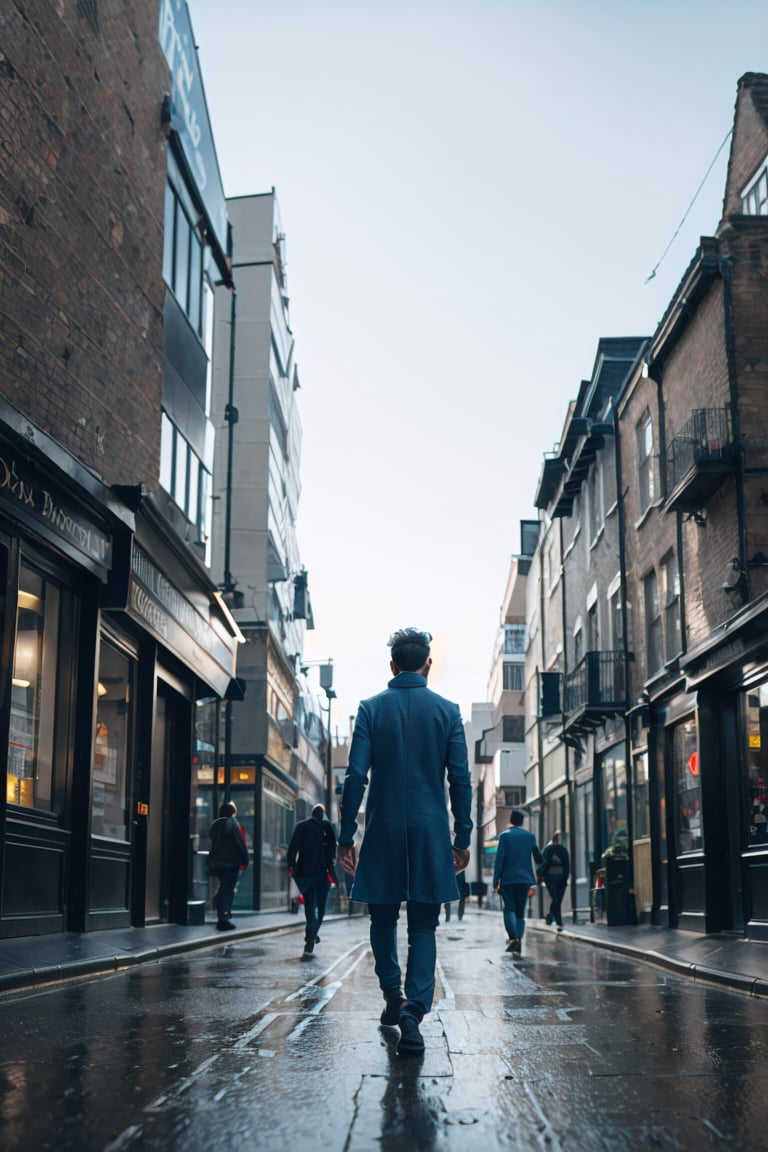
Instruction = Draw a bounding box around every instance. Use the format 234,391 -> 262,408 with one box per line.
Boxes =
0,454 -> 112,578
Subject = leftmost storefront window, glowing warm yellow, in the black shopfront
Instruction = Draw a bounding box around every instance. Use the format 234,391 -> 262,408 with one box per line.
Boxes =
7,564 -> 61,811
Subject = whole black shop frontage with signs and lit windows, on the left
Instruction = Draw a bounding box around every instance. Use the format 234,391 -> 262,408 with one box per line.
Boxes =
0,402 -> 239,938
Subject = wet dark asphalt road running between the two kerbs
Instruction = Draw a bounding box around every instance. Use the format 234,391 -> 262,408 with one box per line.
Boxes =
0,910 -> 768,1152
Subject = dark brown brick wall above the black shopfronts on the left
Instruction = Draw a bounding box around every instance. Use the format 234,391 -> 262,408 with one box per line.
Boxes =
0,0 -> 169,487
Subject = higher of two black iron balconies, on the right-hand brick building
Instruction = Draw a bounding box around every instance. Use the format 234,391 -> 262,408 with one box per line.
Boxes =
664,408 -> 737,513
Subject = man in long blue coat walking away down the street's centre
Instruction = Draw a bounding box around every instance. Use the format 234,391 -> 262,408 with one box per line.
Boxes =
339,628 -> 472,1055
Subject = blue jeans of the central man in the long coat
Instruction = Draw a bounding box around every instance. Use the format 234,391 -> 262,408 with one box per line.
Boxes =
368,900 -> 440,1023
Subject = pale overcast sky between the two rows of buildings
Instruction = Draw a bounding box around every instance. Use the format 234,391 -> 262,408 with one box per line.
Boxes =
189,0 -> 768,735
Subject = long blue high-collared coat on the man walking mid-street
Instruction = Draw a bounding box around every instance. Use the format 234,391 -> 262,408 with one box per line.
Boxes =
339,672 -> 472,904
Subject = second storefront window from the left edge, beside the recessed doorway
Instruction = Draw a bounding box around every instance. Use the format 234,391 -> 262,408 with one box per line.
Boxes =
91,637 -> 132,840
